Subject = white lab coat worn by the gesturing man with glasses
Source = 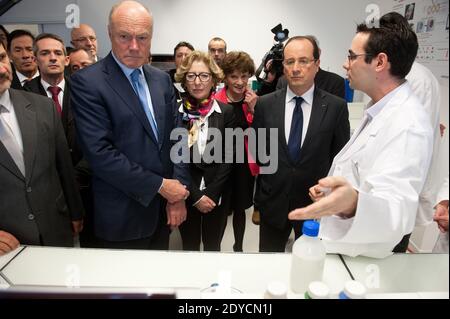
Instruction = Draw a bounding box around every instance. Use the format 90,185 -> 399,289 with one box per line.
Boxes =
320,83 -> 433,258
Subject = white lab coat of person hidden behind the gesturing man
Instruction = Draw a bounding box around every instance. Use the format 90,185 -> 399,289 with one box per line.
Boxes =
406,62 -> 444,226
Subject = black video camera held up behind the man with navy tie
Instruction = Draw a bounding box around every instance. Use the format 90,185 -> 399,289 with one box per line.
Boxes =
255,23 -> 289,84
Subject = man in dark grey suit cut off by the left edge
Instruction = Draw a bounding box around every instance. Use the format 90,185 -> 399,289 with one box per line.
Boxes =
0,43 -> 83,255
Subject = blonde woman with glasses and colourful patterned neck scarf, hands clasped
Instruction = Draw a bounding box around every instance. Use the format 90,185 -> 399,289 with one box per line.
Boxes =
175,51 -> 234,251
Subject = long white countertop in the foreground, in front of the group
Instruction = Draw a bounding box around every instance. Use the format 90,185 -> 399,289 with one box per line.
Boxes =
0,246 -> 449,299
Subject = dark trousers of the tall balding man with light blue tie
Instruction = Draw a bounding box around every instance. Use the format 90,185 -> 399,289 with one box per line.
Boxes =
96,216 -> 170,250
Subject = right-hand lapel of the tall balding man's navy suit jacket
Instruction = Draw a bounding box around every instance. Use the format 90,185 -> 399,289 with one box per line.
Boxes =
142,65 -> 166,148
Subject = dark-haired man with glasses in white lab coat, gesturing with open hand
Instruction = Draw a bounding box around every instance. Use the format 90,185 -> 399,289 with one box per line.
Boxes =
289,18 -> 433,258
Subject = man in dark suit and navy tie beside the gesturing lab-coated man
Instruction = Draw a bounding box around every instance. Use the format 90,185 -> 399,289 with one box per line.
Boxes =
253,36 -> 350,252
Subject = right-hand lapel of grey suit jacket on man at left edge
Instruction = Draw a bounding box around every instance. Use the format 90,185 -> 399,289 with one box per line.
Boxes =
10,90 -> 37,181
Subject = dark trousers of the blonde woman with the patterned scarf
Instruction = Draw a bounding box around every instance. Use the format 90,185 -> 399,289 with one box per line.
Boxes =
179,206 -> 227,251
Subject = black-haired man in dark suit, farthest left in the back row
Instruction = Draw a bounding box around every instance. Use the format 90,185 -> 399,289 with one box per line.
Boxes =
8,30 -> 39,90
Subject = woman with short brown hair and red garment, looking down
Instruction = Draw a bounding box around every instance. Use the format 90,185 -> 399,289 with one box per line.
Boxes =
216,51 -> 259,252
